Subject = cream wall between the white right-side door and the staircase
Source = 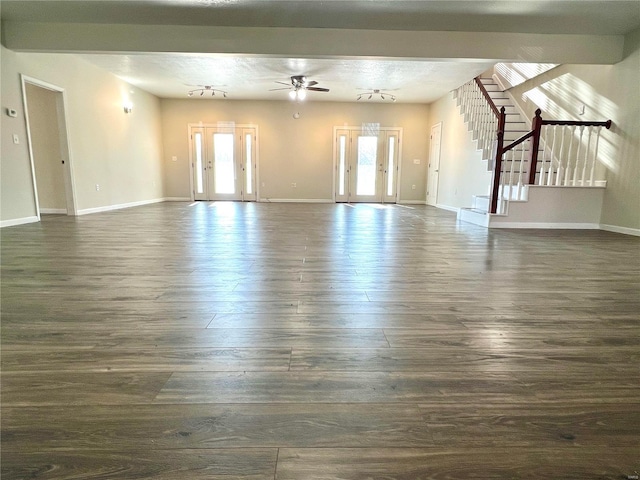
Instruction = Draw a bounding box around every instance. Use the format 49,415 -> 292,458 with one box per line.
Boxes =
429,94 -> 491,208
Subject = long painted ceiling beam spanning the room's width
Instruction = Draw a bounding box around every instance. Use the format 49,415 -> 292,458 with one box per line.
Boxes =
2,21 -> 624,64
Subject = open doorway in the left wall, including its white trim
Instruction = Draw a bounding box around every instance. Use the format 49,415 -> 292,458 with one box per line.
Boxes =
21,75 -> 77,219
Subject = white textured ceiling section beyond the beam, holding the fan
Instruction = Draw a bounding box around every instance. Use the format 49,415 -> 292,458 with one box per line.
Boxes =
76,54 -> 493,103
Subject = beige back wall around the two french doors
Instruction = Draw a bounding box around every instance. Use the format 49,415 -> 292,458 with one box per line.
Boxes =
162,95 -> 429,202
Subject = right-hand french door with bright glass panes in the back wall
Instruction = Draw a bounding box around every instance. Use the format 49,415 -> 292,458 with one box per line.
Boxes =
335,128 -> 400,203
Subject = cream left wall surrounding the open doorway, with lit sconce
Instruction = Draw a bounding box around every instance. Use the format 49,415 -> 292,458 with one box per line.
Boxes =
0,47 -> 164,224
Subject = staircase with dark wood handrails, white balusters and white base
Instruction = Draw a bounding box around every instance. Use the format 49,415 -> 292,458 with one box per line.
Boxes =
454,78 -> 611,228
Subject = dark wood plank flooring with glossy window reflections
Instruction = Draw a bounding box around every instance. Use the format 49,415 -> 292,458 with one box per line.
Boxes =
0,202 -> 640,480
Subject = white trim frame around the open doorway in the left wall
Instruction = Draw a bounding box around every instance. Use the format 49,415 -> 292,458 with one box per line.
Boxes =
20,74 -> 78,221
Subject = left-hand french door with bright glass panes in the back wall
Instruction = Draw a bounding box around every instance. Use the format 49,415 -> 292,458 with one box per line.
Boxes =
190,126 -> 257,201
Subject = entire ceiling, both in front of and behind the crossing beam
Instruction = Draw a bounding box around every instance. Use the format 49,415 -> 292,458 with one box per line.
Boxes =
0,0 -> 640,103
